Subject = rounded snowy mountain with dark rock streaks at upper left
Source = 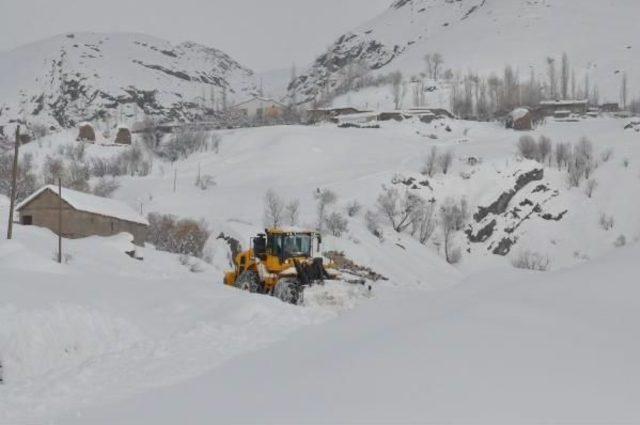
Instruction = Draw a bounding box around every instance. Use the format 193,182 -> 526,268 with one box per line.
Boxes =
0,33 -> 255,128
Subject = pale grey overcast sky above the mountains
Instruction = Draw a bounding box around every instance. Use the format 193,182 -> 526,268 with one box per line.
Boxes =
0,0 -> 392,71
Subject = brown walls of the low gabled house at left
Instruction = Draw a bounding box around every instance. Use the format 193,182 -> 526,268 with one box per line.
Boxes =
19,190 -> 147,246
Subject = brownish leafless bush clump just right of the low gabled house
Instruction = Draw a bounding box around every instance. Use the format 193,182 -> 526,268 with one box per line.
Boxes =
147,213 -> 210,258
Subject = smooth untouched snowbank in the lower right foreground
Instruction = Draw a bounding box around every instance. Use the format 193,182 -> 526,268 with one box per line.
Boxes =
60,242 -> 640,425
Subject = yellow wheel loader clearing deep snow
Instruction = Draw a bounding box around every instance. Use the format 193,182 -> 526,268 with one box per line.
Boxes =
224,228 -> 339,304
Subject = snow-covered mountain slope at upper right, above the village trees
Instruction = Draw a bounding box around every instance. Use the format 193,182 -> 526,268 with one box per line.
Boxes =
290,0 -> 640,101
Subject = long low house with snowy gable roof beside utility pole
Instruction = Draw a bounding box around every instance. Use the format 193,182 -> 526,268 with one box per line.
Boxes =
16,185 -> 149,246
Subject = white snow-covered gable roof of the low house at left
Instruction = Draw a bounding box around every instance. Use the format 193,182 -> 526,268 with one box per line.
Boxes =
16,185 -> 149,225
